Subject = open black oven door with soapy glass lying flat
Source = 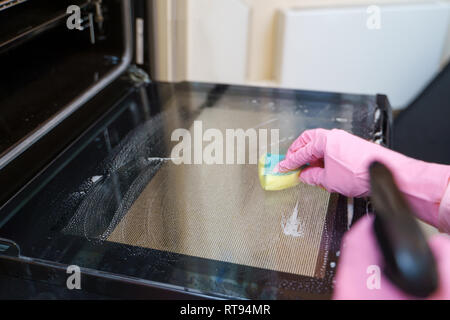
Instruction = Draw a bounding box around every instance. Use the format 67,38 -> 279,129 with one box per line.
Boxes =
0,76 -> 390,299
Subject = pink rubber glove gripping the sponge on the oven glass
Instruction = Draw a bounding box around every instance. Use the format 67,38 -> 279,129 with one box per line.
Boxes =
278,129 -> 450,232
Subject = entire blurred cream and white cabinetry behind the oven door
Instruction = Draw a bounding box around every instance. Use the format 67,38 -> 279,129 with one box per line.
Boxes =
151,0 -> 450,108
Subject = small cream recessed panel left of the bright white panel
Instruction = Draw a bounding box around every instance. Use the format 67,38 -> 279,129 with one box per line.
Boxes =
187,0 -> 249,83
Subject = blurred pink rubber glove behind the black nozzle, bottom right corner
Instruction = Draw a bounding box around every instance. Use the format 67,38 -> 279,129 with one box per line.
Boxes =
333,216 -> 450,300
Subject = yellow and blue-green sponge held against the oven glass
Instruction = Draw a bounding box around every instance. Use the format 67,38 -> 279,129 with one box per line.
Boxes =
258,153 -> 300,191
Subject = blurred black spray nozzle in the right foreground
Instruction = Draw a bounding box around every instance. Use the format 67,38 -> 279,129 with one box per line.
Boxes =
369,162 -> 438,298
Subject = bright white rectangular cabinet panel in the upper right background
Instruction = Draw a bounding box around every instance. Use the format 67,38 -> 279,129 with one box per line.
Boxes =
275,3 -> 449,107
